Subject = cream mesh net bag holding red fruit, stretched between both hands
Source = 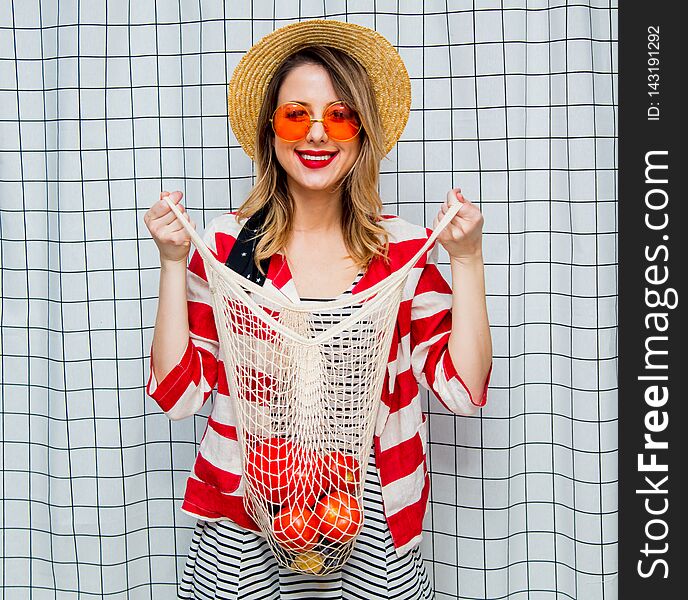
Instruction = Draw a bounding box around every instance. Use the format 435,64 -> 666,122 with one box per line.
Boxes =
166,198 -> 460,575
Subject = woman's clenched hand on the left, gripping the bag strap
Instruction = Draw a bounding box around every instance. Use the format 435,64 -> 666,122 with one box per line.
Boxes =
143,191 -> 196,263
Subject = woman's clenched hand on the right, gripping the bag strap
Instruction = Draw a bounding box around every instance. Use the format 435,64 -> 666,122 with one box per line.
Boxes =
432,188 -> 484,261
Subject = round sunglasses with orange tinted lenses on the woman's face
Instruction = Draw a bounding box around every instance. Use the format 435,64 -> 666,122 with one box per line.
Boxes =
270,100 -> 362,142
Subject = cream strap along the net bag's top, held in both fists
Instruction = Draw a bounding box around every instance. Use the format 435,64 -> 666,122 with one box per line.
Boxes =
164,196 -> 463,312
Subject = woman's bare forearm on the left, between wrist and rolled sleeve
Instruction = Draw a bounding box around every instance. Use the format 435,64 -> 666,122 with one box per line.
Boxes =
151,260 -> 189,381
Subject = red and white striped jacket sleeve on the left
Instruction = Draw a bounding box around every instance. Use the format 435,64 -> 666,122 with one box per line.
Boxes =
146,221 -> 219,421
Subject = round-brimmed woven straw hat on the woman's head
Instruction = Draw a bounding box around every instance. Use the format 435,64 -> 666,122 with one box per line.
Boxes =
227,19 -> 411,160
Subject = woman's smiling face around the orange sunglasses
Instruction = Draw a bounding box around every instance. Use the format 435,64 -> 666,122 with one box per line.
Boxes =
273,64 -> 361,198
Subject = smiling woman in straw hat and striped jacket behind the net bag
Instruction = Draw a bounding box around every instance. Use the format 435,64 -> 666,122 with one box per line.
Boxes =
144,20 -> 492,600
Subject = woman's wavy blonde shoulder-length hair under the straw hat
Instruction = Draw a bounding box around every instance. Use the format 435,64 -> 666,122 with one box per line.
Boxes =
236,45 -> 389,275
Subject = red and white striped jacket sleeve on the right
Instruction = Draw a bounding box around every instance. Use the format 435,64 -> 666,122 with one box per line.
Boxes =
411,230 -> 492,415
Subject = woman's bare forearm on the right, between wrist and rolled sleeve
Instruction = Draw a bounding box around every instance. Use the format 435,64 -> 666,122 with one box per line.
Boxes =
449,254 -> 492,401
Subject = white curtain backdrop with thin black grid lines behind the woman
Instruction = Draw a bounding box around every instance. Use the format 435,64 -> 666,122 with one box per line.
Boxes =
0,0 -> 618,600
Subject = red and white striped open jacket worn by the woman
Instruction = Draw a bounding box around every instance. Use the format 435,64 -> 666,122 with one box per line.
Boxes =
146,212 -> 492,556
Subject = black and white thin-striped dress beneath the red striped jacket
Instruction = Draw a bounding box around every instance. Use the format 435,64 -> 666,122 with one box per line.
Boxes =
177,273 -> 434,600
